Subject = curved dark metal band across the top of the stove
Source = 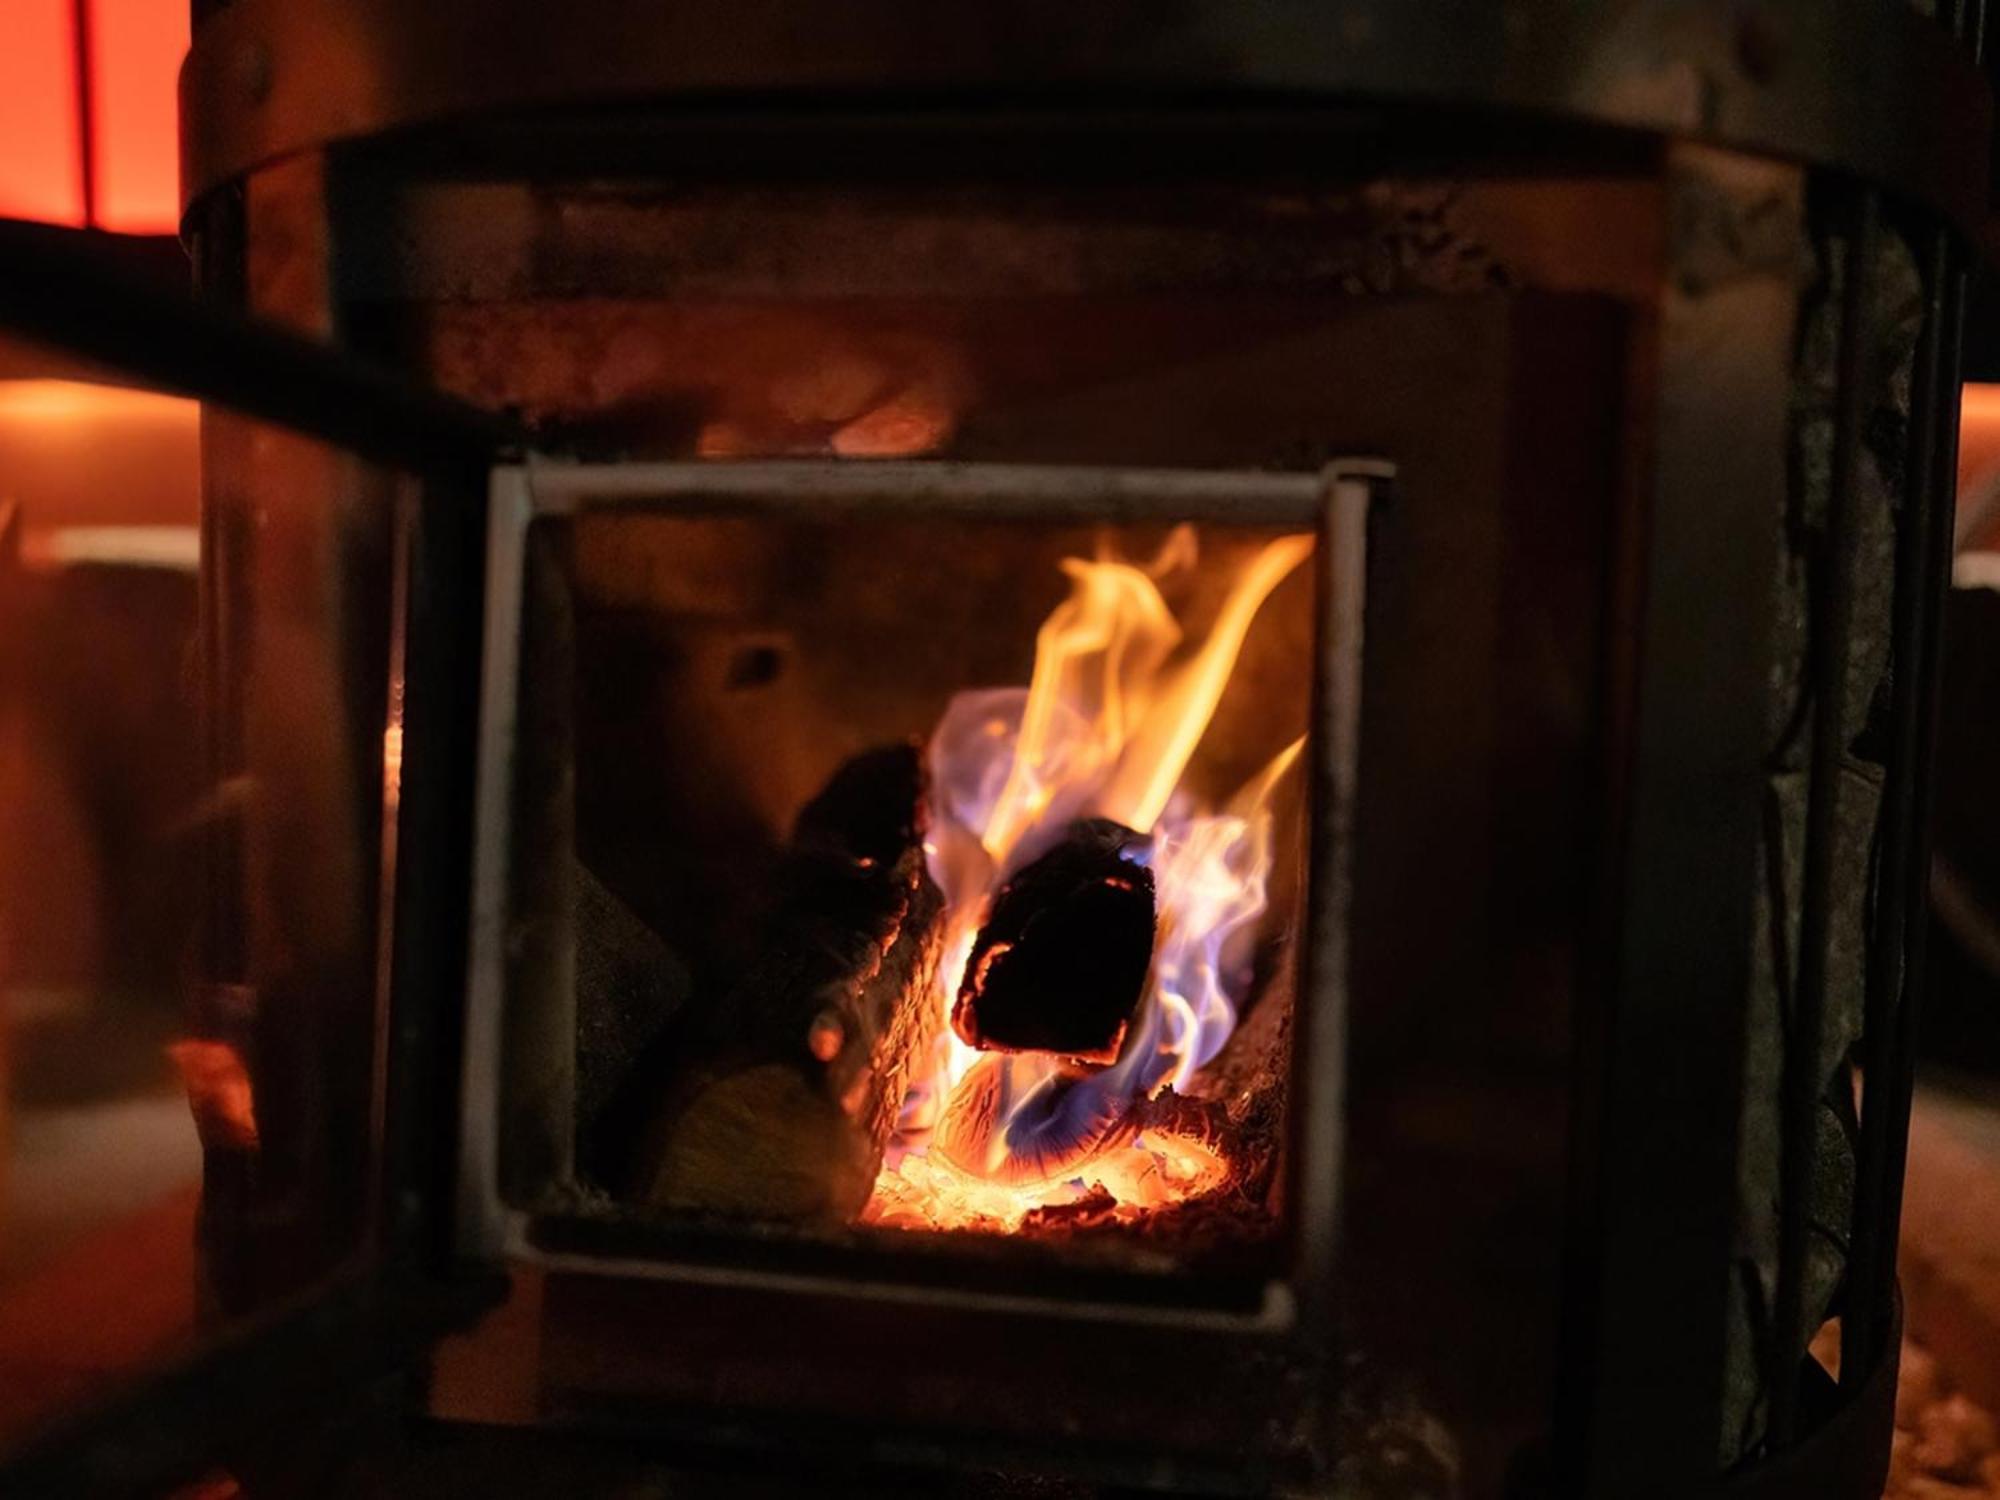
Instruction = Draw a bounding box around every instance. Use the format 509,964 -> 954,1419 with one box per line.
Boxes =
182,0 -> 1990,230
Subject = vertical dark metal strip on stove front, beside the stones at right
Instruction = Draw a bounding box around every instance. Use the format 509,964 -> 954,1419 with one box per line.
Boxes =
1556,148 -> 1800,1500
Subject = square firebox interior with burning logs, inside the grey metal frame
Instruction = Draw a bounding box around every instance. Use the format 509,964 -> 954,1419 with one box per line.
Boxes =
504,508 -> 1314,1252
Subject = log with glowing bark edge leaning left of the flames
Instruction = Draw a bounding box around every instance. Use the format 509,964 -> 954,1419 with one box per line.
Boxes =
636,746 -> 944,1220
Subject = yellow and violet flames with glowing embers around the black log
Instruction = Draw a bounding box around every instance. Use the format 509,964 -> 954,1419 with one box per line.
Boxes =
862,528 -> 1312,1232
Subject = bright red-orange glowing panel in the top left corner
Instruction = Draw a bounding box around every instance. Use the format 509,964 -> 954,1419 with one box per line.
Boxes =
0,0 -> 188,234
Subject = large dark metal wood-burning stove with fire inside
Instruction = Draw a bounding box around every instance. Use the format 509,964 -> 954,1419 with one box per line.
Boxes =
0,0 -> 1986,1496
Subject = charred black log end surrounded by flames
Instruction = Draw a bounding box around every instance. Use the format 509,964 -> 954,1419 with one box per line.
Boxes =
952,818 -> 1156,1066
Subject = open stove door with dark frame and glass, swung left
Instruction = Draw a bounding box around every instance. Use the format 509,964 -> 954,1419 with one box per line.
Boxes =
0,224 -> 502,1494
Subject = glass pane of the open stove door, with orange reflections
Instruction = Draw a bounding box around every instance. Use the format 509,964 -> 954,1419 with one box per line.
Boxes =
0,346 -> 396,1446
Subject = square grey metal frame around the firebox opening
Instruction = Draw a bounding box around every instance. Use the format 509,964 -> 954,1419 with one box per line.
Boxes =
454,458 -> 1394,1338
